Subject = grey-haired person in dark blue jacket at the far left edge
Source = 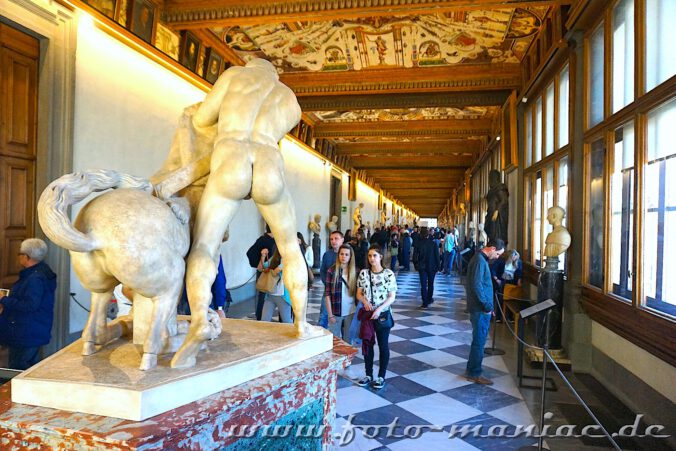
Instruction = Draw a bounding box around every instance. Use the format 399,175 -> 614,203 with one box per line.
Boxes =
0,238 -> 56,370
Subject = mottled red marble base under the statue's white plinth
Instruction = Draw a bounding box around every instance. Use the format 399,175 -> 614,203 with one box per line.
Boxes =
0,339 -> 356,450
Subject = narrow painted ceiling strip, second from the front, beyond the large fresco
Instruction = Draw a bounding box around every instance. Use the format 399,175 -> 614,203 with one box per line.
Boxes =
311,106 -> 499,123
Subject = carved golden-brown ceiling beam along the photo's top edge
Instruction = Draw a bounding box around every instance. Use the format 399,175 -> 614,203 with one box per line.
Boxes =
162,0 -> 574,29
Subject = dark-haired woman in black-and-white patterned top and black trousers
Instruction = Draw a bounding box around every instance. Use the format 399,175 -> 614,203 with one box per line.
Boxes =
357,244 -> 397,389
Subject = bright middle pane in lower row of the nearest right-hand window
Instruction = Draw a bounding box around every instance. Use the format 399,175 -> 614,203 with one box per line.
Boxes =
609,122 -> 634,299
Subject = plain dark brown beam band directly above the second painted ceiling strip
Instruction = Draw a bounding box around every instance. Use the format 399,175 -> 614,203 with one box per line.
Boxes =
296,90 -> 510,112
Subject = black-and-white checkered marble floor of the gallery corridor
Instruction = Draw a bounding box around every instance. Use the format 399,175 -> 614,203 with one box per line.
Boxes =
229,271 -> 669,451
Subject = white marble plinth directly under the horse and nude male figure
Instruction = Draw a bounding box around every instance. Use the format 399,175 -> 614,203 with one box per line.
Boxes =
12,319 -> 333,421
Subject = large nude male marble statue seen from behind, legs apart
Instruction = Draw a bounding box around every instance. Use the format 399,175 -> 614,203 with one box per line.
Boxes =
171,59 -> 317,367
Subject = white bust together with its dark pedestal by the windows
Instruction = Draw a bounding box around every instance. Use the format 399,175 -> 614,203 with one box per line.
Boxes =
537,206 -> 570,349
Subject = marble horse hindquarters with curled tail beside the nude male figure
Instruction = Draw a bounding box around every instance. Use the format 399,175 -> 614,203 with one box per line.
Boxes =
38,170 -> 220,370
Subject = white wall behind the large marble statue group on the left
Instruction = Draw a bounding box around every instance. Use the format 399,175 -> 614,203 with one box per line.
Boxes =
70,21 -> 332,333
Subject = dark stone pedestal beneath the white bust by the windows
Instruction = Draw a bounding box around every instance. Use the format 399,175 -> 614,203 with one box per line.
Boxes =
537,257 -> 563,349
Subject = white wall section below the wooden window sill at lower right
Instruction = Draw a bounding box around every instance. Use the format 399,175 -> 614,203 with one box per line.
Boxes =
592,321 -> 676,402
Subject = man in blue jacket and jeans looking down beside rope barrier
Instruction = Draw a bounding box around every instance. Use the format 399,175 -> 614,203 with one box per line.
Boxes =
466,239 -> 505,385
